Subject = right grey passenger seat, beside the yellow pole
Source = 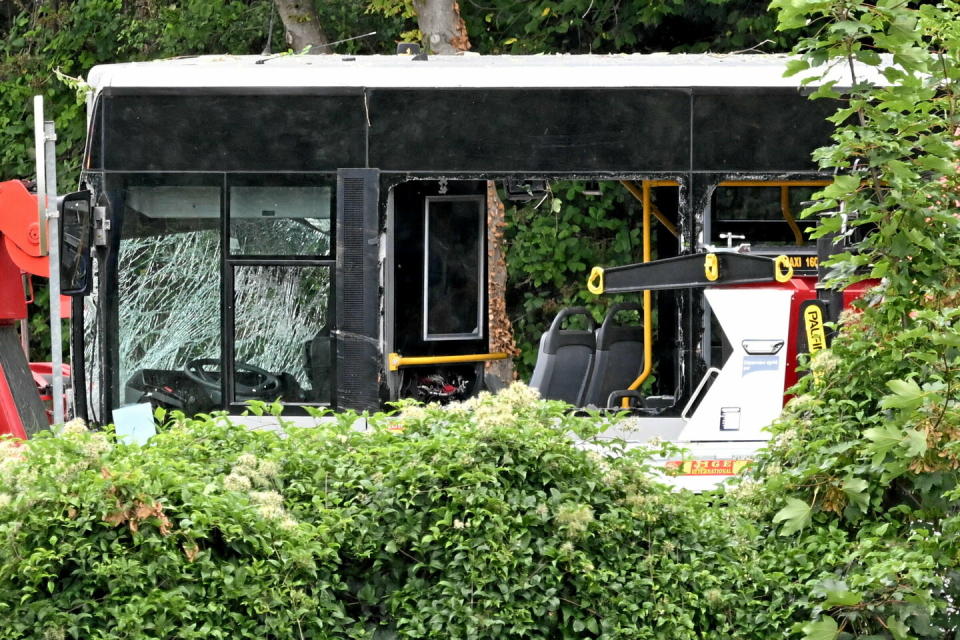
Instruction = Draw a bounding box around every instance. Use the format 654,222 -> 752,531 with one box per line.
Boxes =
584,302 -> 643,407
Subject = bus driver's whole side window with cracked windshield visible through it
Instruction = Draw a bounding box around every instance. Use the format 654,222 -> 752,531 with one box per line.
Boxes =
114,175 -> 333,413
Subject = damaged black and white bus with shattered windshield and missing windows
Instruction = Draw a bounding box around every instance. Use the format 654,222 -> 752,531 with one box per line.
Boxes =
58,54 -> 872,484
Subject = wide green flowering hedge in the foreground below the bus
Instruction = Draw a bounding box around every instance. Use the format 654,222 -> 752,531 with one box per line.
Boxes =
0,385 -> 820,640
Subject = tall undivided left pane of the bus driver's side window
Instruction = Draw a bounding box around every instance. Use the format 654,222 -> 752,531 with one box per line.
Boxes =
114,187 -> 221,412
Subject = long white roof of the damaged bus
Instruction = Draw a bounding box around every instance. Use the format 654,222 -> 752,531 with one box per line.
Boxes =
88,53 -> 882,92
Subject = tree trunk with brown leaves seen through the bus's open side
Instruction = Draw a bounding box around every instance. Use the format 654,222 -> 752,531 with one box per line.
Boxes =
487,180 -> 519,384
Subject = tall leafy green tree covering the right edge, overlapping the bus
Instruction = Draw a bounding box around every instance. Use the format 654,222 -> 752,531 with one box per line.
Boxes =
736,0 -> 960,640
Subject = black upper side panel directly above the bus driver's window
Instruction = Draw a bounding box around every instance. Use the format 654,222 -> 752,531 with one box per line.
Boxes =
103,94 -> 366,171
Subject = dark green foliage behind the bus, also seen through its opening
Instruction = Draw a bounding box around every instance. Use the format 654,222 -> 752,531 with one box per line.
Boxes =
0,0 -> 795,368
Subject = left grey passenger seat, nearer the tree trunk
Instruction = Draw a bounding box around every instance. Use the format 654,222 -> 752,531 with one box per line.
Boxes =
530,307 -> 597,407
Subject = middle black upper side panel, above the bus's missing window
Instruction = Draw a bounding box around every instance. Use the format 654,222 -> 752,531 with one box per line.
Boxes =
370,88 -> 690,172
